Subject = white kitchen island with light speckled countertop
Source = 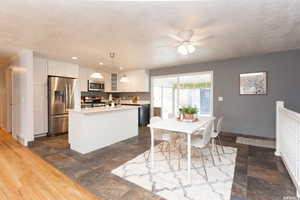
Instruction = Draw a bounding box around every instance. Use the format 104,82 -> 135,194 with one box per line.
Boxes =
69,106 -> 138,154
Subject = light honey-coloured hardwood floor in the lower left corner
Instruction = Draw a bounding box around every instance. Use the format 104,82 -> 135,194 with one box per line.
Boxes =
0,129 -> 97,200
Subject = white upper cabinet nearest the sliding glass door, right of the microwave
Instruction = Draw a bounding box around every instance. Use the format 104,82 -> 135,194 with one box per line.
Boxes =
119,69 -> 149,92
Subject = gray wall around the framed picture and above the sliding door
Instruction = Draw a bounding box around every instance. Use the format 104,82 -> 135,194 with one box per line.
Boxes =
150,50 -> 300,138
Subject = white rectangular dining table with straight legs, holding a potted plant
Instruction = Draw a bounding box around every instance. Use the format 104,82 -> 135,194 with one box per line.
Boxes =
148,117 -> 215,183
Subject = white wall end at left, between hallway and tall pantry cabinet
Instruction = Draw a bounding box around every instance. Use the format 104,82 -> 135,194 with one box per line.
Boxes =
10,50 -> 34,146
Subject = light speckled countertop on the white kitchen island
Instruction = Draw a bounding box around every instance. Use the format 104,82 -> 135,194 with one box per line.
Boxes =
69,106 -> 138,114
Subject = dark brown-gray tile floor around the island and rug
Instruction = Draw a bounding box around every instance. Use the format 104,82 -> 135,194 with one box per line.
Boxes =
30,128 -> 296,200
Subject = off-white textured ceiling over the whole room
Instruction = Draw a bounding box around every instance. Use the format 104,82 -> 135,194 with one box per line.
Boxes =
0,0 -> 300,69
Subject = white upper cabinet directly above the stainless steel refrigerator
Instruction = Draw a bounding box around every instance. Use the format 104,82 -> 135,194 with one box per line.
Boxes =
48,60 -> 79,78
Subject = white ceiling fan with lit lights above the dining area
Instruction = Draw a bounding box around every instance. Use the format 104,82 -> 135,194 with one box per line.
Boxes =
168,29 -> 211,55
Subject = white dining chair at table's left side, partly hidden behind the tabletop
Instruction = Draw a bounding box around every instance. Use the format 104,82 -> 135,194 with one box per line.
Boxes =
147,117 -> 178,160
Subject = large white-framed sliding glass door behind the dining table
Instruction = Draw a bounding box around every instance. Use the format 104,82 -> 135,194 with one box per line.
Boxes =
151,72 -> 213,119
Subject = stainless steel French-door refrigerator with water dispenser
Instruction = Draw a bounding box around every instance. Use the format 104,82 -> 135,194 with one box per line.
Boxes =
48,76 -> 78,135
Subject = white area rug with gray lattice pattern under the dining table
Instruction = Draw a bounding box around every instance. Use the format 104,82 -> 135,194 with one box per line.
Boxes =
112,146 -> 237,200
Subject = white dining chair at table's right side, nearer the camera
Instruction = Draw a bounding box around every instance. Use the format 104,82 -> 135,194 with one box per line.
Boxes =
191,121 -> 215,181
